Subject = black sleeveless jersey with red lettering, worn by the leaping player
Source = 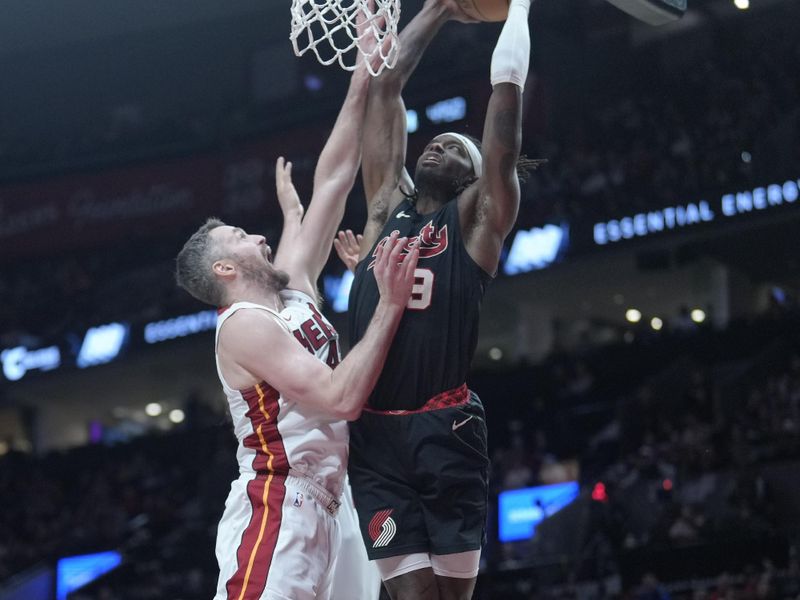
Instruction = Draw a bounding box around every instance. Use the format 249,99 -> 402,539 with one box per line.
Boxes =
349,200 -> 491,410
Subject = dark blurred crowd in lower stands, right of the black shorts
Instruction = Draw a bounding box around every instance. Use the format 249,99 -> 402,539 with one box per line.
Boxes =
481,312 -> 800,599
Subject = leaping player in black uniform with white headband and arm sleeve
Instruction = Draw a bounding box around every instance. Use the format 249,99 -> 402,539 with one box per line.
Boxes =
349,0 -> 531,600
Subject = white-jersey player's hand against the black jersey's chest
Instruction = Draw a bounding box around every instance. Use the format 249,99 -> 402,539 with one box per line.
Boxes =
374,232 -> 419,307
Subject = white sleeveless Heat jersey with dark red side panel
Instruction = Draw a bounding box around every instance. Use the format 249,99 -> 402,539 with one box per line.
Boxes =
215,290 -> 348,497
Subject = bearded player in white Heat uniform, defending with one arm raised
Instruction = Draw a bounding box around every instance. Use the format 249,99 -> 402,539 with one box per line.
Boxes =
172,34 -> 418,600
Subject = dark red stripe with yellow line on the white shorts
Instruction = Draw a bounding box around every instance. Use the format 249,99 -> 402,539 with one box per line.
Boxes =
225,473 -> 286,600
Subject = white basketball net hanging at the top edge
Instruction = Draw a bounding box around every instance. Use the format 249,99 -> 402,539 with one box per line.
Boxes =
290,0 -> 400,75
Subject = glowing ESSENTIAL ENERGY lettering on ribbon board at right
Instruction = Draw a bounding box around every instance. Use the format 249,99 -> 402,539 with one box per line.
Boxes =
594,179 -> 800,246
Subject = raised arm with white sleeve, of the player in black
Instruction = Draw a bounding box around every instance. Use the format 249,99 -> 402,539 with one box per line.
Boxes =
459,0 -> 531,274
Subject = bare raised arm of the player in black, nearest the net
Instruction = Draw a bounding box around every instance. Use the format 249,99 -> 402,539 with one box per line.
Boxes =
361,0 -> 456,258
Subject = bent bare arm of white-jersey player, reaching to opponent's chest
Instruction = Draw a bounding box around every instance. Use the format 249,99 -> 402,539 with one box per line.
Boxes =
219,235 -> 419,420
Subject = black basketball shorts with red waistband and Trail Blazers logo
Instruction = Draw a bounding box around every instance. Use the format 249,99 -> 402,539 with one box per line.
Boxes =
348,385 -> 489,560
